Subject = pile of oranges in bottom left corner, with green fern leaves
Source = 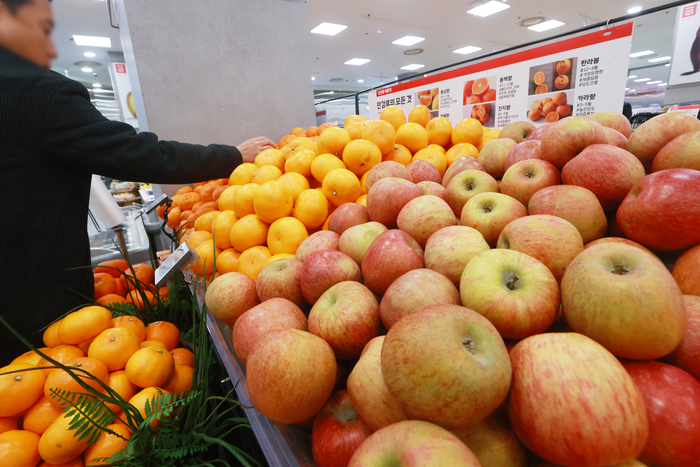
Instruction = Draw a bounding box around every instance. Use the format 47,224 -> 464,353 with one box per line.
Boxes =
0,306 -> 194,466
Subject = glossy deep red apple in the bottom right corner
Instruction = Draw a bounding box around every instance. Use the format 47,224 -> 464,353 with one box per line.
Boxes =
622,361 -> 700,467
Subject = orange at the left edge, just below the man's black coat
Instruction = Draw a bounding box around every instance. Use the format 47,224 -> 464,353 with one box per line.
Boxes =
0,363 -> 46,417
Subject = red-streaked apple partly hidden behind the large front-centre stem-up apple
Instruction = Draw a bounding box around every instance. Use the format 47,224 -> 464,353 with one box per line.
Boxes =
379,268 -> 462,329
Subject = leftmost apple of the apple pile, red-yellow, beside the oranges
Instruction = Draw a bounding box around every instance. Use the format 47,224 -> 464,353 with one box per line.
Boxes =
204,272 -> 260,326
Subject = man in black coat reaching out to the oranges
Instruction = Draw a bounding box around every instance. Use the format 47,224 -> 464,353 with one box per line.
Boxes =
0,0 -> 276,366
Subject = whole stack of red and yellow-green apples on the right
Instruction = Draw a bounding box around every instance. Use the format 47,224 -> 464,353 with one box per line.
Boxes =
206,106 -> 700,467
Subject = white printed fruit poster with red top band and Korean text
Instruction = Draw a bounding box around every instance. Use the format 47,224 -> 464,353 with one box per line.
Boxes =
369,23 -> 633,128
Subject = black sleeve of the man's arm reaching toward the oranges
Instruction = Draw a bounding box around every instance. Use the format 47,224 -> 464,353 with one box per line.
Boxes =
42,81 -> 243,183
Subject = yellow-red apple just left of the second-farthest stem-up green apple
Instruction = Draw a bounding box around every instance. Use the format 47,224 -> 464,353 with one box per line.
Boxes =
400,195 -> 458,248
